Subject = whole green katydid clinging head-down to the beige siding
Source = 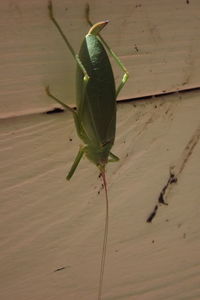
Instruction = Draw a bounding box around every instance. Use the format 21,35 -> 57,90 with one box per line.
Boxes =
46,1 -> 128,300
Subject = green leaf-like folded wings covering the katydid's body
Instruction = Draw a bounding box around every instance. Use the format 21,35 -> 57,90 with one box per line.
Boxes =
77,34 -> 116,144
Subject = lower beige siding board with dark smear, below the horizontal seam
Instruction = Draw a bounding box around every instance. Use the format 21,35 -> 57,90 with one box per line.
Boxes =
0,91 -> 200,300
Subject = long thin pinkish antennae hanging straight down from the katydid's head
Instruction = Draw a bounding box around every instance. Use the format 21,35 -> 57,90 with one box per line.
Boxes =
98,169 -> 109,300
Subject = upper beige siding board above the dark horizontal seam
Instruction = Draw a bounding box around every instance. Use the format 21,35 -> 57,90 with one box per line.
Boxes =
0,0 -> 200,118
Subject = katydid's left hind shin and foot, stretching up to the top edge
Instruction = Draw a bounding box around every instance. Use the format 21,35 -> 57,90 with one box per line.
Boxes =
48,1 -> 89,84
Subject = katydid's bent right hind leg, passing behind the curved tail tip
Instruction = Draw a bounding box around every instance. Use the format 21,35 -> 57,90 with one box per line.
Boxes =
85,4 -> 129,97
